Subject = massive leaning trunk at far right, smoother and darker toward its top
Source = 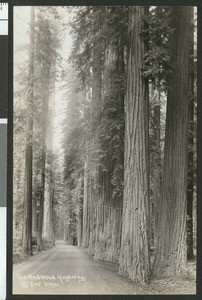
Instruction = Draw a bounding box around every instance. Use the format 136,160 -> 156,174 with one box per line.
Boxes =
154,6 -> 193,277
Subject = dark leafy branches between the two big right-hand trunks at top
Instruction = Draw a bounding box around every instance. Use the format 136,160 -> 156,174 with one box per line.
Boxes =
143,6 -> 172,91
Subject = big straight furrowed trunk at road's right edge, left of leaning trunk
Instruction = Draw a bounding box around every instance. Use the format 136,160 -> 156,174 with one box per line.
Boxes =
119,6 -> 150,282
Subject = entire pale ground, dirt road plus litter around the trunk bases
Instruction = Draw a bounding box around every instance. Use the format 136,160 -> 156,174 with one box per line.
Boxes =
13,241 -> 196,295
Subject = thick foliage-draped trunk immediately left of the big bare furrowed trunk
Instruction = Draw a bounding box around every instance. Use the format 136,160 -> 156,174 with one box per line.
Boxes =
95,34 -> 124,262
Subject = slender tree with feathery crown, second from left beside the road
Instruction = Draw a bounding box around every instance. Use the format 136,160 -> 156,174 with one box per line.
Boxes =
36,8 -> 53,250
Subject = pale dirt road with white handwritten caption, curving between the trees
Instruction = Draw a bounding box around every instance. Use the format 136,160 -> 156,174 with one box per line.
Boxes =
13,241 -> 136,294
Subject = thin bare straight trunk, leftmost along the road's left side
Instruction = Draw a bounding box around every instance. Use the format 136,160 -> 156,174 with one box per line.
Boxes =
22,7 -> 35,255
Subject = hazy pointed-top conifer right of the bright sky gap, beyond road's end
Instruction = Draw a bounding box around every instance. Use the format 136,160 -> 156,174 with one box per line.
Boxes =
63,64 -> 87,246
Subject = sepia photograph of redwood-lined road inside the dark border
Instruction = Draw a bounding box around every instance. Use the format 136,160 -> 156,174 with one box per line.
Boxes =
12,6 -> 197,295
